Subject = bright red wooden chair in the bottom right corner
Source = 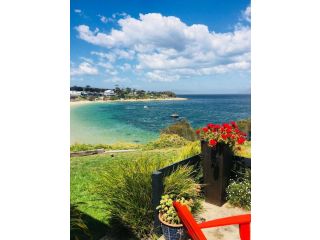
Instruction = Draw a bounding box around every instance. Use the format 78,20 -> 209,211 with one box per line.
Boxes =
173,202 -> 251,240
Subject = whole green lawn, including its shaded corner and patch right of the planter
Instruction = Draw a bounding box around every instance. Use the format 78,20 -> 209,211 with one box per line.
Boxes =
70,142 -> 251,239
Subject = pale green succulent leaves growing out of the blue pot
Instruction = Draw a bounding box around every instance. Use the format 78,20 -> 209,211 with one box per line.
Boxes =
157,194 -> 193,225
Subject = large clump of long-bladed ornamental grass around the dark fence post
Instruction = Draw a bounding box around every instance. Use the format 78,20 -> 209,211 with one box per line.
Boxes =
96,155 -> 199,239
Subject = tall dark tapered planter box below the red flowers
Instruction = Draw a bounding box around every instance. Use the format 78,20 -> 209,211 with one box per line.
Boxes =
201,141 -> 233,206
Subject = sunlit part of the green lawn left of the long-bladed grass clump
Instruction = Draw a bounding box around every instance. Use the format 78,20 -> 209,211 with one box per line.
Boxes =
70,148 -> 184,239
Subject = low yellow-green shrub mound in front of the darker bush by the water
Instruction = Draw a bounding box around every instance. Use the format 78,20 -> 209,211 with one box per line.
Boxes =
142,134 -> 190,150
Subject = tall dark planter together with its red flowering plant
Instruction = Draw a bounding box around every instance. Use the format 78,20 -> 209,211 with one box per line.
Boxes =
196,122 -> 246,206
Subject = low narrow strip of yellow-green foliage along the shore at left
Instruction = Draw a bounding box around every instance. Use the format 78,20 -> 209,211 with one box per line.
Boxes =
70,143 -> 140,152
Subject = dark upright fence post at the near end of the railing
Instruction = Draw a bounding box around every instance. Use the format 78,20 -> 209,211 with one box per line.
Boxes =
152,171 -> 164,234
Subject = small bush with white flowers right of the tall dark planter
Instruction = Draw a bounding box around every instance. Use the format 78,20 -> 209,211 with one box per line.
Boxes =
226,170 -> 251,210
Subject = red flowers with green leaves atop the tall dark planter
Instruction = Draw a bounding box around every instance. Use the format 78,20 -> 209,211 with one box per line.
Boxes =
196,122 -> 247,147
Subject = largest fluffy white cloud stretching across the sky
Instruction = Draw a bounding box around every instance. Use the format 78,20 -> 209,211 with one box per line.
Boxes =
76,10 -> 251,81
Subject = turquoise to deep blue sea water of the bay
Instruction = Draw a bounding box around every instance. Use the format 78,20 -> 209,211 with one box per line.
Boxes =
70,95 -> 251,143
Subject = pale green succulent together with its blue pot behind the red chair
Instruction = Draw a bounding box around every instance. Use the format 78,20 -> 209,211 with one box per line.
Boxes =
157,194 -> 194,240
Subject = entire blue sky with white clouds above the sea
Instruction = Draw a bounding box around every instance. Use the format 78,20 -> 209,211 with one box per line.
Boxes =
70,0 -> 251,94
